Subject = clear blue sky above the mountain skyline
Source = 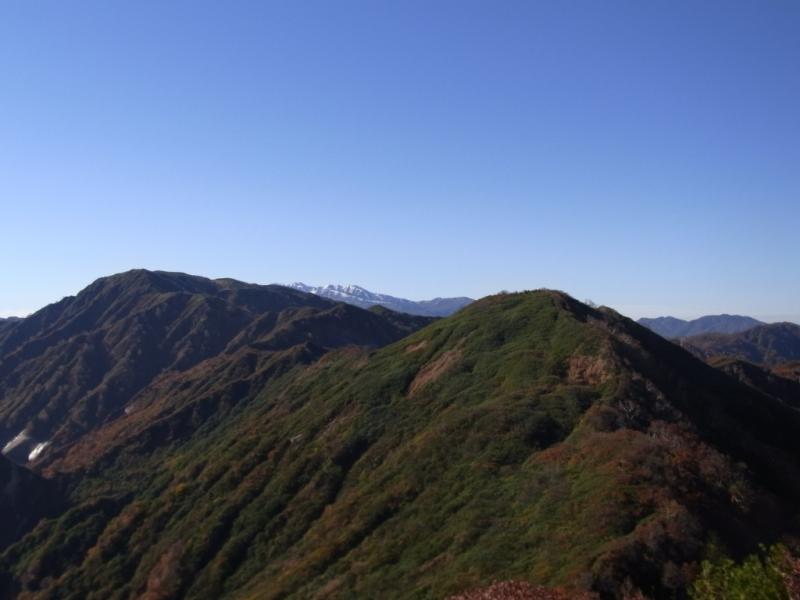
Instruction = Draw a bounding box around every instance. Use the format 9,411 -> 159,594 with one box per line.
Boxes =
0,0 -> 800,320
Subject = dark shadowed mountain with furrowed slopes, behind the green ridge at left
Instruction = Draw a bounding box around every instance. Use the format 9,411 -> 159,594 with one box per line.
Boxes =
0,270 -> 428,463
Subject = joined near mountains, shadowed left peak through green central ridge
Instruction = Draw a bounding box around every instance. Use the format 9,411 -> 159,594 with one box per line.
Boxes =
0,271 -> 800,600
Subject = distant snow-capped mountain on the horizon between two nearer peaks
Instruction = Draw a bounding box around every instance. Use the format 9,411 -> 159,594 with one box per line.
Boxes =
289,282 -> 473,317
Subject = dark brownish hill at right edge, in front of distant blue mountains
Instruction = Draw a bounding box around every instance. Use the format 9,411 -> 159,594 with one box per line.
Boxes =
680,323 -> 800,366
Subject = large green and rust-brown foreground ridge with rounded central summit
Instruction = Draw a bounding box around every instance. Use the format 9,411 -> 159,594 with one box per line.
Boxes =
0,291 -> 800,598
